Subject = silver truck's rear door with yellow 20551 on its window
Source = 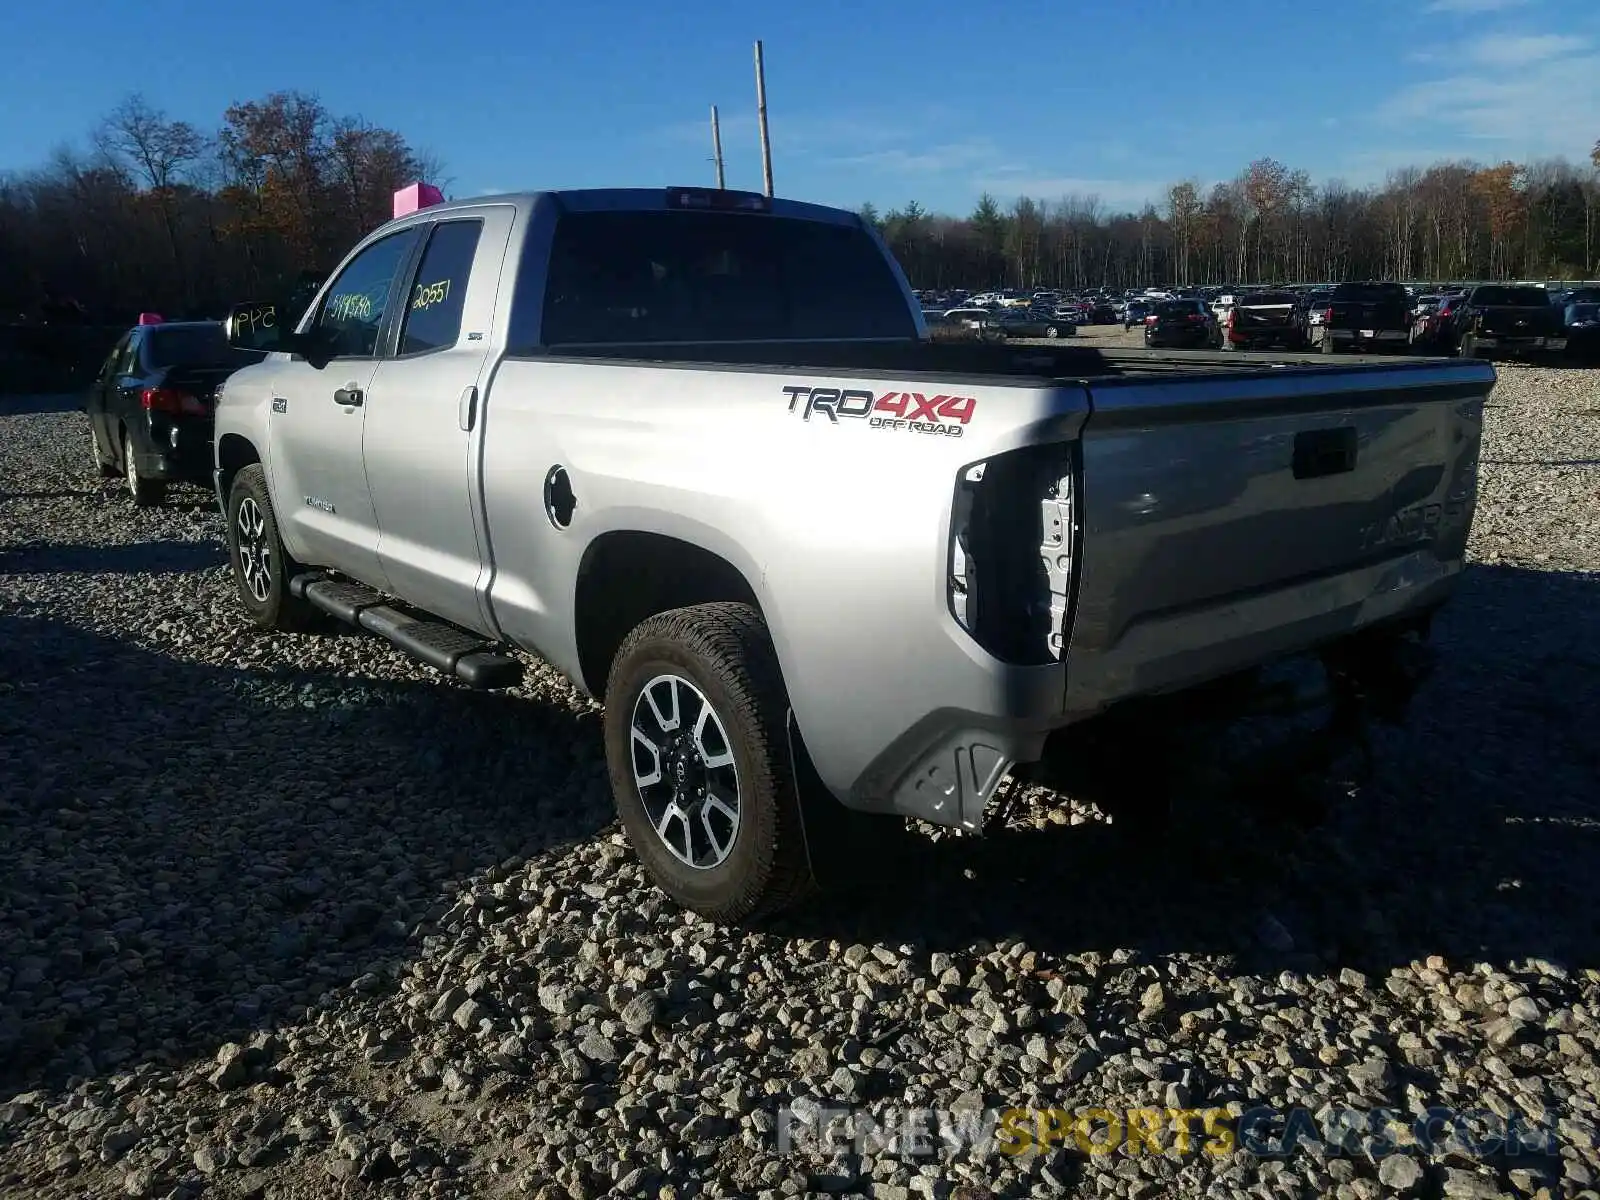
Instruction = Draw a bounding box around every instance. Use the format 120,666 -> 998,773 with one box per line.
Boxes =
362,205 -> 515,632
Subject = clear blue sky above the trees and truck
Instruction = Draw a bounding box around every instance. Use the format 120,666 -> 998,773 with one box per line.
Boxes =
0,0 -> 1600,213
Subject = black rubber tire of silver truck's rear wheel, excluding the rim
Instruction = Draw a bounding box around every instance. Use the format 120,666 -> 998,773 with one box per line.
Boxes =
605,603 -> 813,925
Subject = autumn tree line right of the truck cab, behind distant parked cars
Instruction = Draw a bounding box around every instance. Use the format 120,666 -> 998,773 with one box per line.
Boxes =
862,142 -> 1600,288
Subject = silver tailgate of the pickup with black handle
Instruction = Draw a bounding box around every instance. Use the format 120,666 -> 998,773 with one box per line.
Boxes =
1067,362 -> 1494,712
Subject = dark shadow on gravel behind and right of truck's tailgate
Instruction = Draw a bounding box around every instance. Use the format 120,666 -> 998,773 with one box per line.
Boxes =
778,566 -> 1600,971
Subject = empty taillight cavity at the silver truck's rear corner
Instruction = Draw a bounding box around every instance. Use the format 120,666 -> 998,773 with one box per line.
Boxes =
947,442 -> 1078,666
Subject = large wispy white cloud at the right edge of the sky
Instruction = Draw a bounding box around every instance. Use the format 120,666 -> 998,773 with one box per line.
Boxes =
1378,34 -> 1600,160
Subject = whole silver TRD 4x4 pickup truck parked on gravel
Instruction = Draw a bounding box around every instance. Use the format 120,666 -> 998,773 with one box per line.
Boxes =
216,189 -> 1494,920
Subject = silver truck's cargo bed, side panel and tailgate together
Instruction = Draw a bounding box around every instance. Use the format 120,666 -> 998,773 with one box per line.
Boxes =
485,342 -> 1494,800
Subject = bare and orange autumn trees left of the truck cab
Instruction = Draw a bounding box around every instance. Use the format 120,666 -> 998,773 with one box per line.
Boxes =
0,91 -> 438,323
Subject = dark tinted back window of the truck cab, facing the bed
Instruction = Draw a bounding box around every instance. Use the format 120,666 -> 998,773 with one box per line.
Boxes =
534,213 -> 917,346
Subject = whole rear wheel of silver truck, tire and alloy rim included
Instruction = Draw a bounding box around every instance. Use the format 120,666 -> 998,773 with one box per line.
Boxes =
605,603 -> 811,923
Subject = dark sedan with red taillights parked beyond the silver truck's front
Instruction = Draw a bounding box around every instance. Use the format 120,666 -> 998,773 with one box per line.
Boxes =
83,322 -> 264,507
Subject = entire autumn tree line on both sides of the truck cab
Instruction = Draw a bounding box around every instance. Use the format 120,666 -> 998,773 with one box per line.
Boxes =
0,91 -> 1600,323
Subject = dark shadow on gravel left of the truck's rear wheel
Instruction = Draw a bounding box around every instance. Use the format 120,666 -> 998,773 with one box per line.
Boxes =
0,614 -> 611,1094
